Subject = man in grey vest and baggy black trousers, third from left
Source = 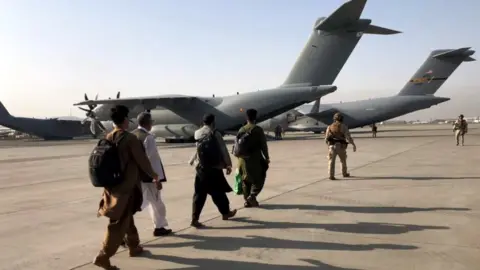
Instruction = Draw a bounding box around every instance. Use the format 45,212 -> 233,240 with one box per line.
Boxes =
189,114 -> 237,228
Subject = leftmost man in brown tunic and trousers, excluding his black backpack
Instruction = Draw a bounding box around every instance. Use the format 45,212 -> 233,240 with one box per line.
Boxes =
93,106 -> 158,270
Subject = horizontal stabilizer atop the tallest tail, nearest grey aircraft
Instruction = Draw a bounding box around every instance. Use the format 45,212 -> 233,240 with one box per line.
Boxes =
314,0 -> 401,35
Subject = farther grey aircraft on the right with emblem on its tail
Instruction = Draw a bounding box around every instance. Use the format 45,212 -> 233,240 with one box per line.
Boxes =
287,47 -> 475,132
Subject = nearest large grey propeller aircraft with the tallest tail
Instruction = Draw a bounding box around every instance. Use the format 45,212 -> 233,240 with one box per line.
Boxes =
75,0 -> 400,141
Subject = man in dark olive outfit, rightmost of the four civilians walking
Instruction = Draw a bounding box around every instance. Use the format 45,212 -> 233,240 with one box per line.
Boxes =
237,109 -> 270,207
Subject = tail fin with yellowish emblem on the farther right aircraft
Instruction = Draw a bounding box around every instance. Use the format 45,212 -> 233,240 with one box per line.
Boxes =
398,47 -> 475,96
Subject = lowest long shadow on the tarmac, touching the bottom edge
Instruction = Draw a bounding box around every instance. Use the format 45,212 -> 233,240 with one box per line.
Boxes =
145,252 -> 360,270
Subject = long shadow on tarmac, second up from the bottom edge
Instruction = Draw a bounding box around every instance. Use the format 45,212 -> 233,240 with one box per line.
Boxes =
150,234 -> 418,253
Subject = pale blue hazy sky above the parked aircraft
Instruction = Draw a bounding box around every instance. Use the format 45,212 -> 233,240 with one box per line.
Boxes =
0,0 -> 480,118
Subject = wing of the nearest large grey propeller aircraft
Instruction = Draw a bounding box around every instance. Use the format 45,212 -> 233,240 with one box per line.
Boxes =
74,95 -> 234,126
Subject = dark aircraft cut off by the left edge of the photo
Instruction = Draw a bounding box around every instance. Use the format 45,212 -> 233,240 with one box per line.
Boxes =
0,102 -> 92,140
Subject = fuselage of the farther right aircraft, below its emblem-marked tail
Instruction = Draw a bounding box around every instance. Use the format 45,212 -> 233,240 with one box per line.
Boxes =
308,95 -> 450,128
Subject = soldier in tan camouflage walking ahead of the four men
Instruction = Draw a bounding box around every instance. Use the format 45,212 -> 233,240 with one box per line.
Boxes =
325,113 -> 357,180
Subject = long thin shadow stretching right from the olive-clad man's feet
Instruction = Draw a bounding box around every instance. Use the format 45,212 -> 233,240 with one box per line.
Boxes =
261,204 -> 471,214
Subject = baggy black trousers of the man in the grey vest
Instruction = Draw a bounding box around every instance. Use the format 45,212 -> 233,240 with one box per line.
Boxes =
192,168 -> 230,220
